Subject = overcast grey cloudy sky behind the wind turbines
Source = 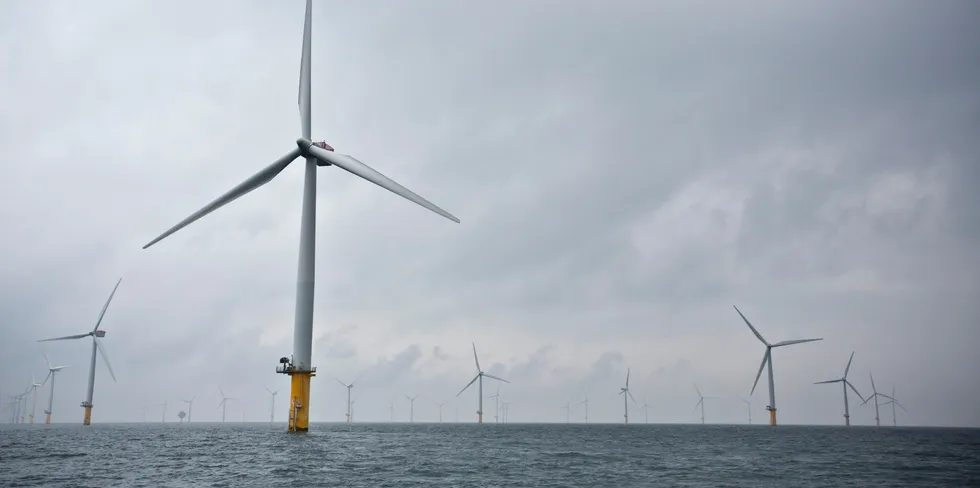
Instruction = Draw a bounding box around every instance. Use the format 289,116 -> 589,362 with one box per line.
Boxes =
0,0 -> 980,427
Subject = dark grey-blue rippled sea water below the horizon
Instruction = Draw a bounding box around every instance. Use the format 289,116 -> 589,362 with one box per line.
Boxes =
0,423 -> 980,488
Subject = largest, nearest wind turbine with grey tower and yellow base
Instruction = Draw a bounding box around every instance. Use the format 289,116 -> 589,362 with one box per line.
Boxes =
143,0 -> 459,432
